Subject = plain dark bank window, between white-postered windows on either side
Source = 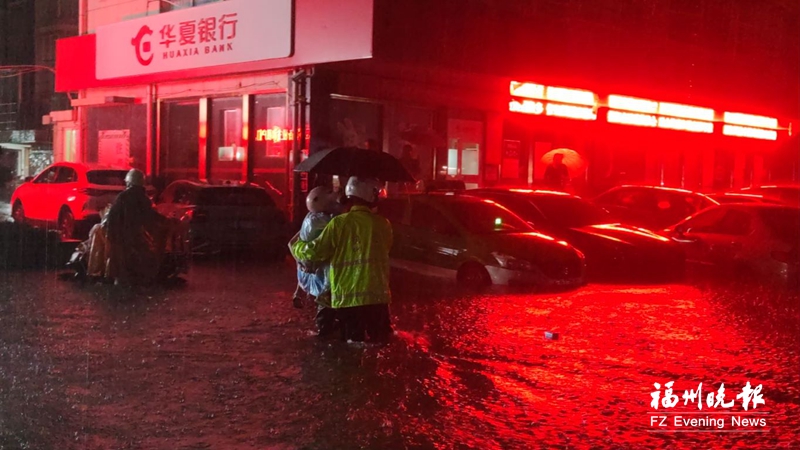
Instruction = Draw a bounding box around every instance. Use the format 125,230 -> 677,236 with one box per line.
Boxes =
158,100 -> 200,182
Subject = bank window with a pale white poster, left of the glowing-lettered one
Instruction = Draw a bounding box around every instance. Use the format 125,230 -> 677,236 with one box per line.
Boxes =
208,97 -> 246,180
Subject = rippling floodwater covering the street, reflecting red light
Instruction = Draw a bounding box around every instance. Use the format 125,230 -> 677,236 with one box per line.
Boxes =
0,262 -> 800,449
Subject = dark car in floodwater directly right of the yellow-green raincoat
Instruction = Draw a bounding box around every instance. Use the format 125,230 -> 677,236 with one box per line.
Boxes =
378,193 -> 585,289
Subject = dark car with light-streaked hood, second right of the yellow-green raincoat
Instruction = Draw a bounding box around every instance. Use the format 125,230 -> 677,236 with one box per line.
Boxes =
467,189 -> 685,279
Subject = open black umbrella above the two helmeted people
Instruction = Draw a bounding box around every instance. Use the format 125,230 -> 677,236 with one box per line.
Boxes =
294,147 -> 414,182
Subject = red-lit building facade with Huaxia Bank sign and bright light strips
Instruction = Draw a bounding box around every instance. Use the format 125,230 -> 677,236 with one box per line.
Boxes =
51,0 -> 800,220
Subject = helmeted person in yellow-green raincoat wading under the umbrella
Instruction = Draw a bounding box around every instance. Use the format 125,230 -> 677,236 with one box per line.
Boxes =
292,177 -> 392,343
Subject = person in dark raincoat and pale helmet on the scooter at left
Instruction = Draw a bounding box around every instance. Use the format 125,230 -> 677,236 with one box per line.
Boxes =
106,169 -> 165,285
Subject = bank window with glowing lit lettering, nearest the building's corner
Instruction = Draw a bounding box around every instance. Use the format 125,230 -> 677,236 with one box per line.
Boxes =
252,93 -> 295,213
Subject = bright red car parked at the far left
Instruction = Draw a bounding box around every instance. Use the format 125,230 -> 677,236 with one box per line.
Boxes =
11,162 -> 152,240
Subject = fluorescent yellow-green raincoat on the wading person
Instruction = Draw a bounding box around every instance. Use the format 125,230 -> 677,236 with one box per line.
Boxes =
292,206 -> 392,308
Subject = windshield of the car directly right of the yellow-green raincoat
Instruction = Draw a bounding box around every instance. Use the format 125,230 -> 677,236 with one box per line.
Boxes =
434,199 -> 532,234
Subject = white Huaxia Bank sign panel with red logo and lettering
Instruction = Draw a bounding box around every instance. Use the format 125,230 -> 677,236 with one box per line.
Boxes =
96,0 -> 292,80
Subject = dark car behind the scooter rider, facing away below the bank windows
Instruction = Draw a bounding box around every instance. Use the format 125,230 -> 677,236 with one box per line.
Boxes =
156,180 -> 288,256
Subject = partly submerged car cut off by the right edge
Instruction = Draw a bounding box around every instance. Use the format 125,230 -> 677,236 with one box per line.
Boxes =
665,204 -> 800,286
